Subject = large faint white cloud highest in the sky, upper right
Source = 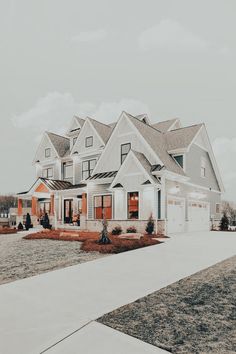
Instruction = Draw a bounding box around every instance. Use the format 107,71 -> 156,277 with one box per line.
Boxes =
138,19 -> 208,51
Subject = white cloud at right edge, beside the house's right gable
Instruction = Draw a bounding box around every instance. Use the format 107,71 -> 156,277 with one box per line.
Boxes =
213,137 -> 236,201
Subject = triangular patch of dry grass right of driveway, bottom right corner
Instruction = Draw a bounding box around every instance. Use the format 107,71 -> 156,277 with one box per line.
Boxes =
98,256 -> 236,354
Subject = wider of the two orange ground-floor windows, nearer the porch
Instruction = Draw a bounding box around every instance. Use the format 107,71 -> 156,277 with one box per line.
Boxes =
94,195 -> 112,219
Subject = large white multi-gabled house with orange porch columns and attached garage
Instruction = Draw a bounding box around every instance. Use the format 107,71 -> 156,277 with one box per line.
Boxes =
18,112 -> 224,233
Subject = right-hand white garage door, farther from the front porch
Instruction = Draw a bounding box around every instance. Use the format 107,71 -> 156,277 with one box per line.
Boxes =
188,201 -> 210,231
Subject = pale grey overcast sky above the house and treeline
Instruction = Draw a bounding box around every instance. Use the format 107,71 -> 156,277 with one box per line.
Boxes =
0,0 -> 236,201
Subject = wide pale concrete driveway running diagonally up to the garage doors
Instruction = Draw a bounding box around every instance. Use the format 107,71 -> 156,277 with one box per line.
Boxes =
0,232 -> 236,354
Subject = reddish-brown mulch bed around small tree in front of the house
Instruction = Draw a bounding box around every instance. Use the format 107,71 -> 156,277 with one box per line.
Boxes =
23,230 -> 161,253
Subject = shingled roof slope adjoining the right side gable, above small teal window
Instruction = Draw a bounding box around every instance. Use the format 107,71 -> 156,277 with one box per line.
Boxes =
165,124 -> 203,151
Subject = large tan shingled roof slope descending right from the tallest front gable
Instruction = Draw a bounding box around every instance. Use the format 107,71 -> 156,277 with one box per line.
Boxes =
125,114 -> 185,176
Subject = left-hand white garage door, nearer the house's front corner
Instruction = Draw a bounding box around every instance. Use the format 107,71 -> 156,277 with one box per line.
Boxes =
167,197 -> 185,234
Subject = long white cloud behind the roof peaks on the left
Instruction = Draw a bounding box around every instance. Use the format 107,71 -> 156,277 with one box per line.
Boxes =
12,92 -> 149,140
